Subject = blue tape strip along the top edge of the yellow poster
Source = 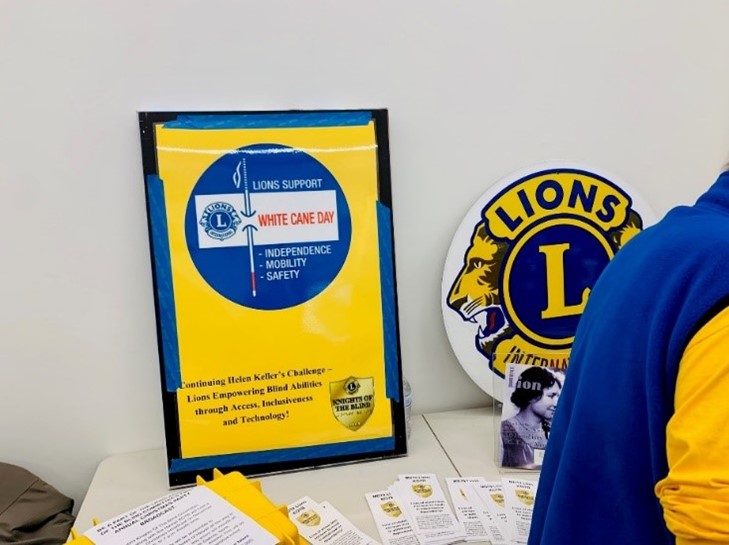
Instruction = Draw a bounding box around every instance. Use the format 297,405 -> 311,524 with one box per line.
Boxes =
164,111 -> 372,130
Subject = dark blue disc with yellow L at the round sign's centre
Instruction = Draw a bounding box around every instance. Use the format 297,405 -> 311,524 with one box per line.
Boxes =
502,221 -> 612,344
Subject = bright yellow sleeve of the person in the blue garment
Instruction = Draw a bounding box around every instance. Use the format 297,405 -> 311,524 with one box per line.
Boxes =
655,308 -> 729,545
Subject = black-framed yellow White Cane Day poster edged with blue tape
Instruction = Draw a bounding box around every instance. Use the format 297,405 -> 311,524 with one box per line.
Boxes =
139,110 -> 406,486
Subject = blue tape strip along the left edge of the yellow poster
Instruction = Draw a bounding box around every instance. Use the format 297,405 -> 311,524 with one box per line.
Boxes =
147,175 -> 182,392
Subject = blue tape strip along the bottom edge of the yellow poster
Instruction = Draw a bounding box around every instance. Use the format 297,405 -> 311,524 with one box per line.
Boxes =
170,437 -> 395,473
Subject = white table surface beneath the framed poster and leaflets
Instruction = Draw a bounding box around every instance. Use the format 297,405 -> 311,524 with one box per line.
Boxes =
75,407 -> 524,540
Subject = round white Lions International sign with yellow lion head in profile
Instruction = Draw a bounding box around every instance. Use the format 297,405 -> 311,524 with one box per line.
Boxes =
441,163 -> 655,400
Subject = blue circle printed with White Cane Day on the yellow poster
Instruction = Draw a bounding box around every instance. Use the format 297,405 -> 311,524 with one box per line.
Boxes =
185,144 -> 352,310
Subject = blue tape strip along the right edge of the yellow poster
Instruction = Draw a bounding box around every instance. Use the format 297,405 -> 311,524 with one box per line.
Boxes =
377,201 -> 400,401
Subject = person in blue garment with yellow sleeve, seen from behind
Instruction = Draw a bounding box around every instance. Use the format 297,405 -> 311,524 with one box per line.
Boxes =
528,168 -> 729,545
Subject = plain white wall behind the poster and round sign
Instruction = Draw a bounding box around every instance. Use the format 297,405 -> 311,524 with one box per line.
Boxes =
0,0 -> 729,508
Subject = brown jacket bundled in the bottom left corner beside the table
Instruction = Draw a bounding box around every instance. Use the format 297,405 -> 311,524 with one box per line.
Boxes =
0,463 -> 73,545
